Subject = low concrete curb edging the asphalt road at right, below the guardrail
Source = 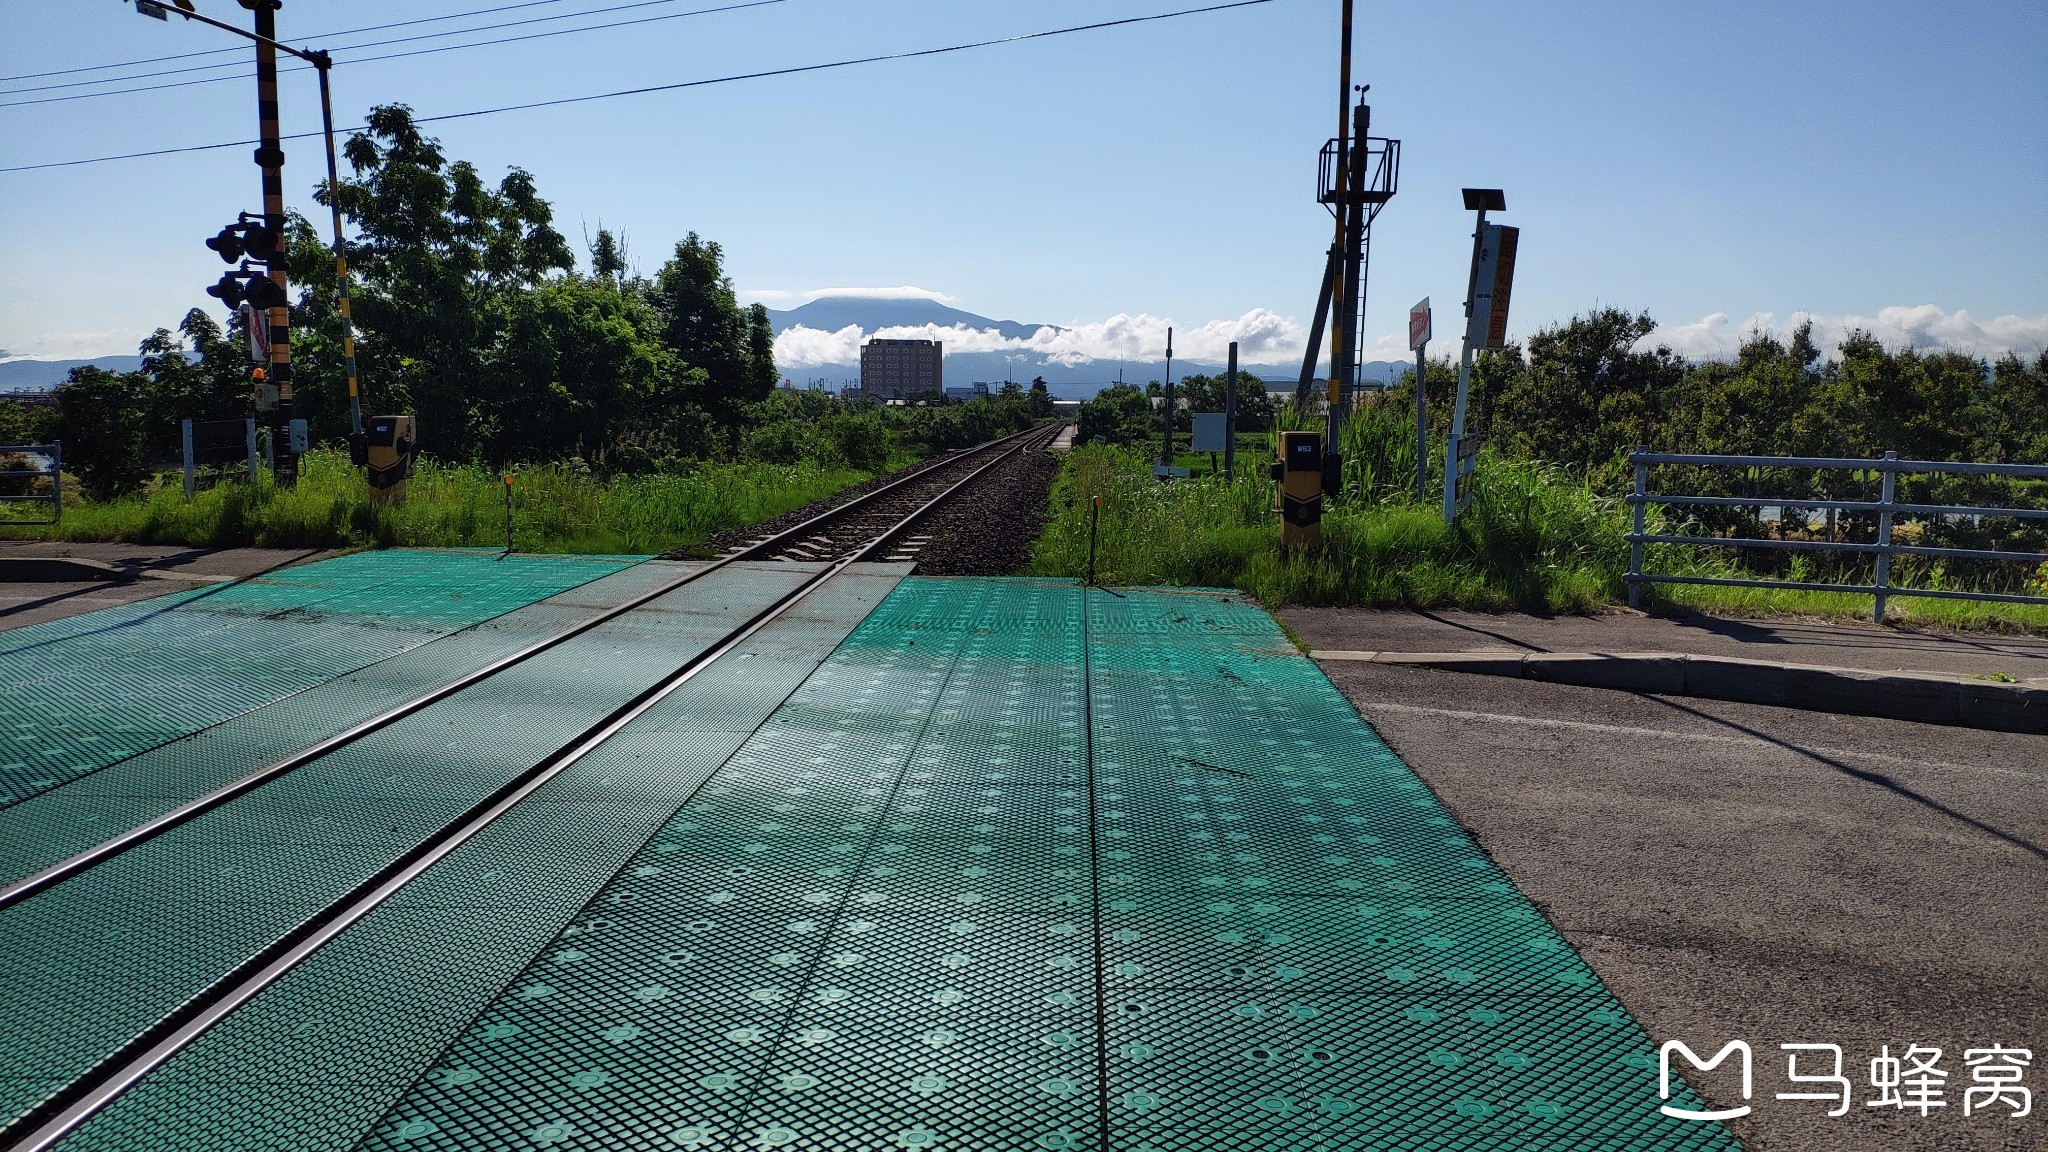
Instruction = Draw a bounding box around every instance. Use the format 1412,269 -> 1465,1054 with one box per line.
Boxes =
1309,650 -> 2048,734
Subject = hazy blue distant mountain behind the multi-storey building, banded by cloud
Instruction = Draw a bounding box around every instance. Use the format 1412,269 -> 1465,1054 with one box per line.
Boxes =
768,295 -> 1409,400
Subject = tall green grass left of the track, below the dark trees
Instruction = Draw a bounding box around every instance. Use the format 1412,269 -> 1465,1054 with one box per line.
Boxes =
0,451 -> 868,556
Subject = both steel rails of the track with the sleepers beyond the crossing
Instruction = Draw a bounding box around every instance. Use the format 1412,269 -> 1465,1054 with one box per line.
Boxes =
0,426 -> 1059,1152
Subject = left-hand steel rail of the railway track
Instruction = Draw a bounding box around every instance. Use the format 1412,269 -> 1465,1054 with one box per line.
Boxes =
0,420 -> 1038,910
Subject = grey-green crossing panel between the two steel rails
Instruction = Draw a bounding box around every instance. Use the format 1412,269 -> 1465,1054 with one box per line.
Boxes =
0,566 -> 805,1123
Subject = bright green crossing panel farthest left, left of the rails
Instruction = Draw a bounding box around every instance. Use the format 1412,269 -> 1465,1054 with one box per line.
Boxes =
0,549 -> 633,808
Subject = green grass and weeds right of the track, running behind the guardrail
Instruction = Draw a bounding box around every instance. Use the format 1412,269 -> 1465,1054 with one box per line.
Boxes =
1032,447 -> 2048,631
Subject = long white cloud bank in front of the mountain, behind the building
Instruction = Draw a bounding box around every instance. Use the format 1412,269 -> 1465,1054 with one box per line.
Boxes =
774,307 -> 1307,367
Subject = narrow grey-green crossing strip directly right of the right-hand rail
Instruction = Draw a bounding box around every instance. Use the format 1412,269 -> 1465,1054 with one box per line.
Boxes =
48,566 -> 907,1152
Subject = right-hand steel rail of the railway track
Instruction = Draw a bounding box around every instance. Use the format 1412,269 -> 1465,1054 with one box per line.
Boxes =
0,428 -> 1042,1152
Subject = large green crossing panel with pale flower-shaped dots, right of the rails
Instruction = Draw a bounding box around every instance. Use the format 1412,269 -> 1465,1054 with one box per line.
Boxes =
331,580 -> 1737,1152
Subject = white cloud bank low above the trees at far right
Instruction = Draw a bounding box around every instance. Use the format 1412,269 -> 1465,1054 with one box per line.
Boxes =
1636,303 -> 2048,361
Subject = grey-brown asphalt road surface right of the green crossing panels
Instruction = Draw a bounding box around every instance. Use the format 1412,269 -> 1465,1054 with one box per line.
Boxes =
1318,655 -> 2048,1152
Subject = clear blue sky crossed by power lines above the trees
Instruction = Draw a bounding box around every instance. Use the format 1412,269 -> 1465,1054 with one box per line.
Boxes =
0,0 -> 2048,361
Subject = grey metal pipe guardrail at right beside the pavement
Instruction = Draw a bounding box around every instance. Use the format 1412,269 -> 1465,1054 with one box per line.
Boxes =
1628,449 -> 2048,621
